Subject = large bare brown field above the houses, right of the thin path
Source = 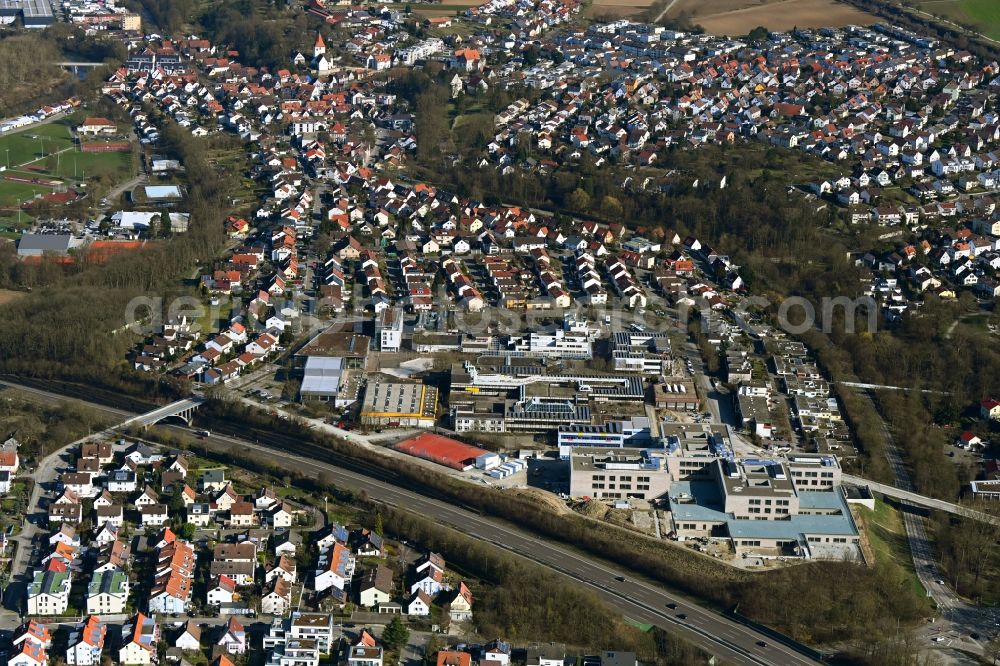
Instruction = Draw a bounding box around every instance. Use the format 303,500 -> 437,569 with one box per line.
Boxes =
667,0 -> 879,35
